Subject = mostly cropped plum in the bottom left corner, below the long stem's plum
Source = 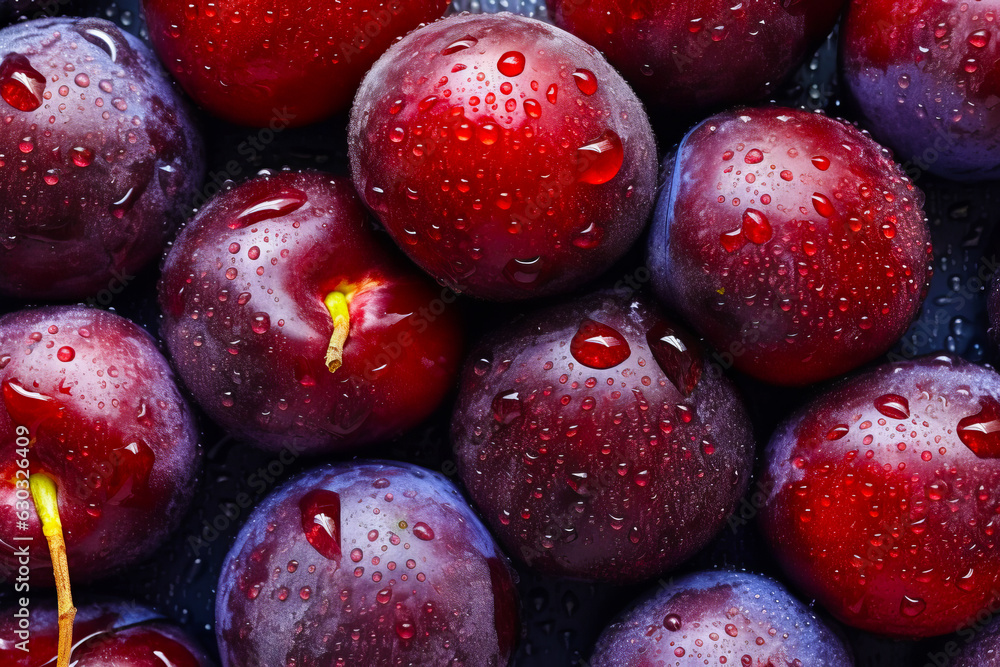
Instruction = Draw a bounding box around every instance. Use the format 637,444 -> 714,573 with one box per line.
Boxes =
0,601 -> 212,667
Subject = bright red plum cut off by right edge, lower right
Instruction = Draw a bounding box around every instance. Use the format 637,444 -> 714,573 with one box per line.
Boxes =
761,356 -> 1000,638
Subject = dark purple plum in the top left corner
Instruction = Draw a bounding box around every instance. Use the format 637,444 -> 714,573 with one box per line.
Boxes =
0,18 -> 205,300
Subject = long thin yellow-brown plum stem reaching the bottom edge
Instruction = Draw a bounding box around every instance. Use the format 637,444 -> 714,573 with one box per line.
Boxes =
28,472 -> 76,667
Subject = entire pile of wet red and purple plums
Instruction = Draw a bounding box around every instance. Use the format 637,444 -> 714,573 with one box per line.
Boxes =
0,0 -> 1000,667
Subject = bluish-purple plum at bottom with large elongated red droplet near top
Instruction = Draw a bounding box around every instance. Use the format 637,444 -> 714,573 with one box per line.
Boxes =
216,460 -> 520,667
